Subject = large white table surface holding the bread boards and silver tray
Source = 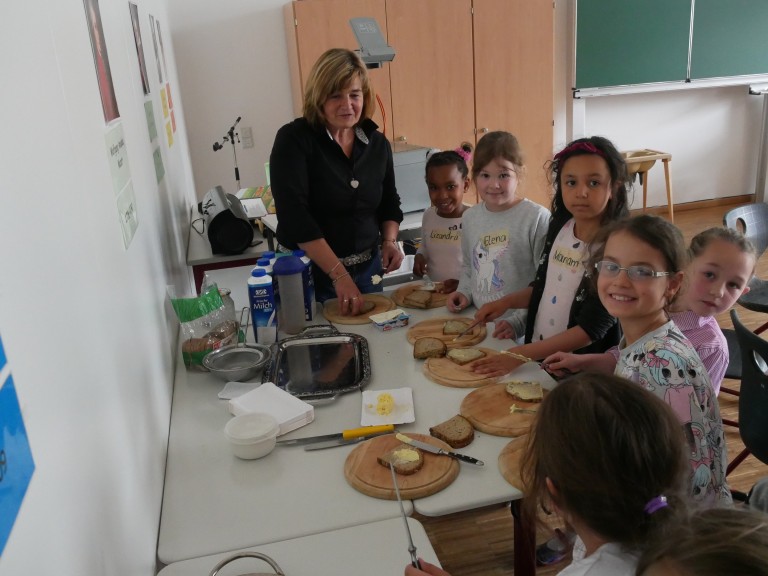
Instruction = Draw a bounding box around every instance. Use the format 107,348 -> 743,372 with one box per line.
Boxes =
158,309 -> 552,564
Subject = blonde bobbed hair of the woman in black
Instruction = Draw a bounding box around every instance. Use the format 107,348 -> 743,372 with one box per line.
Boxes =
303,48 -> 374,127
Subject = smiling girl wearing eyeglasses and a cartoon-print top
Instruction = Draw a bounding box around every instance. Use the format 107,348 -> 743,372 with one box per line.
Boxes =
564,215 -> 731,505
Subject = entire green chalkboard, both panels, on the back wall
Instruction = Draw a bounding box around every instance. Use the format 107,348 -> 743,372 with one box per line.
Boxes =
574,0 -> 768,90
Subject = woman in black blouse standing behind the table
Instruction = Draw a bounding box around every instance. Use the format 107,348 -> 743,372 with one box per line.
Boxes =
269,48 -> 403,314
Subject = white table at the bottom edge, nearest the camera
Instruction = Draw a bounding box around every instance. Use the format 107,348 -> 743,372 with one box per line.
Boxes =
157,518 -> 440,576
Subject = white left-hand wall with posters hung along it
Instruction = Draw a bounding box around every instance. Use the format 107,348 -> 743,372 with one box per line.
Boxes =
0,0 -> 194,576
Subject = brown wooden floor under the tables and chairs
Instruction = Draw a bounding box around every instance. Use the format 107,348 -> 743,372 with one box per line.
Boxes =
415,199 -> 768,576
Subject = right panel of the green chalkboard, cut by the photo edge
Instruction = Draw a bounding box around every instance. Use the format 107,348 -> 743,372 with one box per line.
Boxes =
691,0 -> 768,78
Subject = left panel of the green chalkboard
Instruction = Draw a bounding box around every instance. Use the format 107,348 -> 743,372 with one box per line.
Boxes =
576,0 -> 691,88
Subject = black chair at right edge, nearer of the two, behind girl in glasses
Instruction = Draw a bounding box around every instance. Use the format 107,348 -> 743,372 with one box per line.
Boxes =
726,310 -> 768,476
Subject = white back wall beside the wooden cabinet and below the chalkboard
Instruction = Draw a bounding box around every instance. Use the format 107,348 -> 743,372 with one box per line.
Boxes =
168,0 -> 762,207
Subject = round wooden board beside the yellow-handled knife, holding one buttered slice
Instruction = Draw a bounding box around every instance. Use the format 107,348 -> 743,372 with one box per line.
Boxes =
344,433 -> 459,500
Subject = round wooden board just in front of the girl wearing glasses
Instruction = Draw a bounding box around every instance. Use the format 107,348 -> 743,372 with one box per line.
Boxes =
460,382 -> 546,437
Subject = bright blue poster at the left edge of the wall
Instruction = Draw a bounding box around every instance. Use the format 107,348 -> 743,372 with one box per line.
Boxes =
0,340 -> 35,558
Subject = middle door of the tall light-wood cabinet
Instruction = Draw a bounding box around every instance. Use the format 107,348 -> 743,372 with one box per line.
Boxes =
387,0 -> 475,150
